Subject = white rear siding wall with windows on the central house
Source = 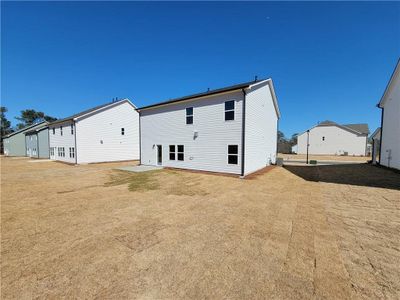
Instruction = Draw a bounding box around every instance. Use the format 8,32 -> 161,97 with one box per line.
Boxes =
141,90 -> 243,174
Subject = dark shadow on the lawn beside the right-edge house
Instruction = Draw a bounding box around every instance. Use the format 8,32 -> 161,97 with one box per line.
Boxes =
284,164 -> 400,190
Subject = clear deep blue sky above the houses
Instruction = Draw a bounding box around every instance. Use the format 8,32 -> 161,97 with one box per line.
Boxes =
1,2 -> 400,136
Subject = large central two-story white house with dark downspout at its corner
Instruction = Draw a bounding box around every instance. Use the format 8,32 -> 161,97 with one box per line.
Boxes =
138,79 -> 280,176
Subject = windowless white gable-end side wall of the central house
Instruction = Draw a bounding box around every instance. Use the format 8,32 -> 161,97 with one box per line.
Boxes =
244,83 -> 278,175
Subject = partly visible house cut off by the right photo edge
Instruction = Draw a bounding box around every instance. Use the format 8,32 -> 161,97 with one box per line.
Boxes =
378,60 -> 400,170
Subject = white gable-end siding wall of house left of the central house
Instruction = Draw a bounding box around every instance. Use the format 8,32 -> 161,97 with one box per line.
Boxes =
75,101 -> 139,164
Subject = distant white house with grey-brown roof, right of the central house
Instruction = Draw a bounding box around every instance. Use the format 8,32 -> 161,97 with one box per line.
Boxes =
297,121 -> 369,156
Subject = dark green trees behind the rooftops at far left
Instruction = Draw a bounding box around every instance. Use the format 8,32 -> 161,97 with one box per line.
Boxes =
0,106 -> 57,154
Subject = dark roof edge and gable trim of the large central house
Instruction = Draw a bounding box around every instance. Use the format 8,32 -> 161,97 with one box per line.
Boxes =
138,78 -> 280,118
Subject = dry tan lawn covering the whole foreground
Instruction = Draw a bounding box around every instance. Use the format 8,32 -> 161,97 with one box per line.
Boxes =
1,158 -> 400,299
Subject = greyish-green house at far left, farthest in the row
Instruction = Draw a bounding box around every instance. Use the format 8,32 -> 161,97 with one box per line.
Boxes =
3,121 -> 47,156
